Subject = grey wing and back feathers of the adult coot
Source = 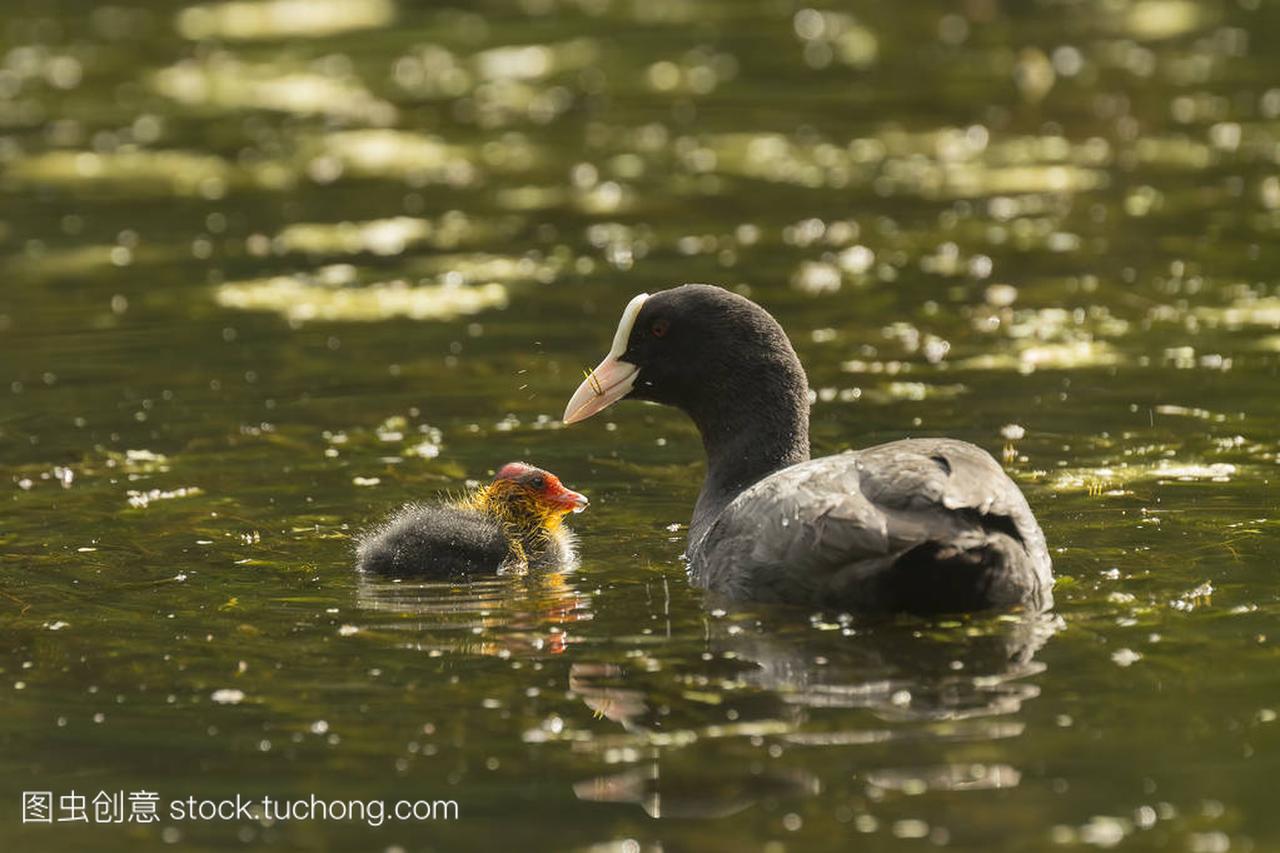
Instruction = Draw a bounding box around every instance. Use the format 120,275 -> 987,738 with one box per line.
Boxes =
690,439 -> 1052,601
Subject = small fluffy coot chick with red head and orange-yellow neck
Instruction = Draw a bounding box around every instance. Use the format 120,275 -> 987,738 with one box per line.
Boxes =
356,462 -> 586,578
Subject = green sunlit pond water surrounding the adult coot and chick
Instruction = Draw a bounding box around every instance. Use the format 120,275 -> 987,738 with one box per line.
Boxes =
0,0 -> 1280,853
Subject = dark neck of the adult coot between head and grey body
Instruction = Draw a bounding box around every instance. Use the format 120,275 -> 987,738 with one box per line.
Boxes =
689,350 -> 809,549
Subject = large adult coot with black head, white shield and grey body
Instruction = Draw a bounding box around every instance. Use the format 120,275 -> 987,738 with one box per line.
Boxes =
564,284 -> 1053,612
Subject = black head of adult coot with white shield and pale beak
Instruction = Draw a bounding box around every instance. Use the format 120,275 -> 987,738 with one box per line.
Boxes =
564,284 -> 803,424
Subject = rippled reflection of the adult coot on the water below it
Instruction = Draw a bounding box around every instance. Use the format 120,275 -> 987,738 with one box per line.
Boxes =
570,608 -> 1061,817
